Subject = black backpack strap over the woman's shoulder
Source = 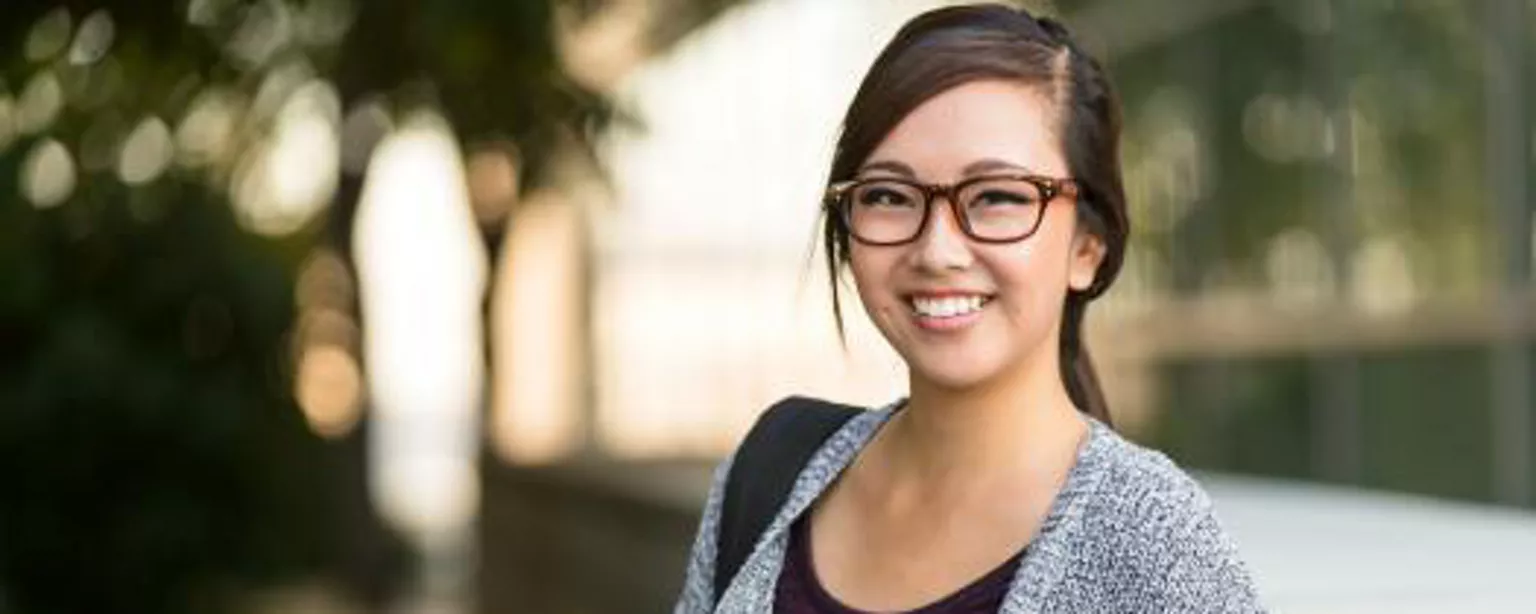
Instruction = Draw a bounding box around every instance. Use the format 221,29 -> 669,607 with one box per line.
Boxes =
714,396 -> 863,600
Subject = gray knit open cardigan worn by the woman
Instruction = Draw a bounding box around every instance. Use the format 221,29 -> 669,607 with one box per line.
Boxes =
673,404 -> 1263,614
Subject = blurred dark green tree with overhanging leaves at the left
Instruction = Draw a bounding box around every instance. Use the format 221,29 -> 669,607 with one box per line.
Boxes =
0,0 -> 733,612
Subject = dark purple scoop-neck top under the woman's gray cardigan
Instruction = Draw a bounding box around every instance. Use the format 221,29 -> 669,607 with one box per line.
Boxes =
773,513 -> 1025,614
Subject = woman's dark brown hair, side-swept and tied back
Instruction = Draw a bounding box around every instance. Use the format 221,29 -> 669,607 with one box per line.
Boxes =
822,5 -> 1130,424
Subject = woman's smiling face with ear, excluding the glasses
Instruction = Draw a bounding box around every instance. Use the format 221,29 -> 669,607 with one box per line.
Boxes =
849,81 -> 1104,390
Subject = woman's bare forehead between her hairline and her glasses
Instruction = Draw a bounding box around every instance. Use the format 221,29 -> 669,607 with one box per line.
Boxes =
865,80 -> 1068,181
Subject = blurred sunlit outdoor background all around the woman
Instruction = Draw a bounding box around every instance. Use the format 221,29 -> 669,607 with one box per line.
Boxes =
0,0 -> 1536,614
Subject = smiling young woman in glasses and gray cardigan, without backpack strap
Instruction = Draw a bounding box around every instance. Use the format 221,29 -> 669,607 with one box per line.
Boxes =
676,6 -> 1261,614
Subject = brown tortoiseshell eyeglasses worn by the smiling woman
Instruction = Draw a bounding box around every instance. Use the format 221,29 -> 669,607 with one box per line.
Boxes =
825,175 -> 1077,246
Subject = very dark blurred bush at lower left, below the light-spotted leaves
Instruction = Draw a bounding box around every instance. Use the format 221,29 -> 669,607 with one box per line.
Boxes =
0,157 -> 332,612
